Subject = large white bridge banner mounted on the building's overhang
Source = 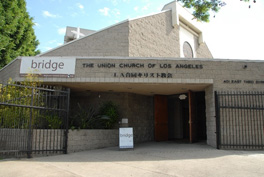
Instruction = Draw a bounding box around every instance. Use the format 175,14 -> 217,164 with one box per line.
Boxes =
20,57 -> 76,76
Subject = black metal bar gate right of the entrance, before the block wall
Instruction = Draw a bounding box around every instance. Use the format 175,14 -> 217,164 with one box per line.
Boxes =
215,92 -> 264,150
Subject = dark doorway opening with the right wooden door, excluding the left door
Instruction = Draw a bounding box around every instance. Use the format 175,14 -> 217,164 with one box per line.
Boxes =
168,92 -> 206,143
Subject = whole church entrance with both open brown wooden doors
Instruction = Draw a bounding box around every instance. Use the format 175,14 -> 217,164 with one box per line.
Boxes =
154,91 -> 206,143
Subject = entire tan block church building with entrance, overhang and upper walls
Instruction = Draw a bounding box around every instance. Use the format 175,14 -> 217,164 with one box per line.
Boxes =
0,1 -> 264,149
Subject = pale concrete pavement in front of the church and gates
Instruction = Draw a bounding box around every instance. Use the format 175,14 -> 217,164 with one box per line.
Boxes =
0,141 -> 264,177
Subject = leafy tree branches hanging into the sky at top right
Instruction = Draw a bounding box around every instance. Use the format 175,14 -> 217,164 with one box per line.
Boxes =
177,0 -> 256,22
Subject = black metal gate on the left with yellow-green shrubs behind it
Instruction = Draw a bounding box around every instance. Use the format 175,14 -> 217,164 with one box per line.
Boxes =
0,84 -> 70,157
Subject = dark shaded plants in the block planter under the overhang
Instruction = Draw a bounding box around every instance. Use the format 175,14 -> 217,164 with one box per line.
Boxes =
69,102 -> 119,129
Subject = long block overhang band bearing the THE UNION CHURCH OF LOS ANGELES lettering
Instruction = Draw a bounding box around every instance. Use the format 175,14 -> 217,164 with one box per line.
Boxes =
0,56 -> 264,95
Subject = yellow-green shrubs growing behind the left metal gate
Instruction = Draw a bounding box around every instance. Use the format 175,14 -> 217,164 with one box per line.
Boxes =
0,74 -> 62,129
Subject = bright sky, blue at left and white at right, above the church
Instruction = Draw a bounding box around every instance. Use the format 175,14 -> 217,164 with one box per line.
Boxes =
26,0 -> 264,60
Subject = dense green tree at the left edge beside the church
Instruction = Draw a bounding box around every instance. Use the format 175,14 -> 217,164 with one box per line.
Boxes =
0,0 -> 40,68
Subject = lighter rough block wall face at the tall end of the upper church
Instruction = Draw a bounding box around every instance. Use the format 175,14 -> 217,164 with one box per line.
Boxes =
129,11 -> 180,57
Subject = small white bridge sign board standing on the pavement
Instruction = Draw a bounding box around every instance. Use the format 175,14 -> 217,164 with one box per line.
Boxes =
119,127 -> 134,149
